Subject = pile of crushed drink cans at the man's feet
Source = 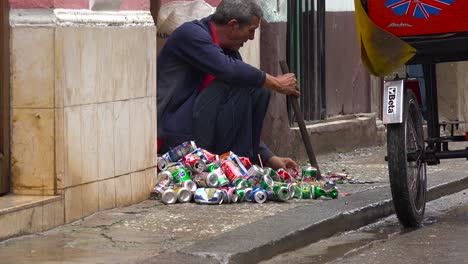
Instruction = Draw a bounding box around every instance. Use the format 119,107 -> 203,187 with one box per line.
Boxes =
151,141 -> 338,204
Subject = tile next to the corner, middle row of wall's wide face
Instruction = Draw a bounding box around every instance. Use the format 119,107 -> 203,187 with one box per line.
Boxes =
63,106 -> 83,188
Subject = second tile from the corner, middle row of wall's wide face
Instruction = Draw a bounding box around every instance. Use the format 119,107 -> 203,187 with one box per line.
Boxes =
80,104 -> 98,183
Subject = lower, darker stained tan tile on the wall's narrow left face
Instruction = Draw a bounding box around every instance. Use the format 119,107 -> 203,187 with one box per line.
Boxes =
11,109 -> 55,195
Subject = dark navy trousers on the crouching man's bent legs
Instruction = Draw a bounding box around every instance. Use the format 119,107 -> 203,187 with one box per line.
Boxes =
193,80 -> 270,160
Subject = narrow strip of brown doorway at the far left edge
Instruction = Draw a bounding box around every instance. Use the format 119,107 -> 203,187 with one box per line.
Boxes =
0,1 -> 10,195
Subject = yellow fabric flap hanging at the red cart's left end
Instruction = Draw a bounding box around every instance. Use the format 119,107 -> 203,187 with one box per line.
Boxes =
354,0 -> 416,76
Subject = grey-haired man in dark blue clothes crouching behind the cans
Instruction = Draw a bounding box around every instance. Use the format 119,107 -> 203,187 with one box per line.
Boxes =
157,0 -> 299,169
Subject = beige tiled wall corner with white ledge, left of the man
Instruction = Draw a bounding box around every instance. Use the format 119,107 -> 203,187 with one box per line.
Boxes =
11,9 -> 157,222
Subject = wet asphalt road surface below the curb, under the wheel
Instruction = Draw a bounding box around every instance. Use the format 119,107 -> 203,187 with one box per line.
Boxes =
262,190 -> 468,264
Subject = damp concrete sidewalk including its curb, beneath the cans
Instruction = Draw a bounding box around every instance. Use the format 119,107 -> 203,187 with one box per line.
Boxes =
0,147 -> 468,263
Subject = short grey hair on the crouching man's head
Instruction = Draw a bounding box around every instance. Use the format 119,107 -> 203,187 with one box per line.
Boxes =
213,0 -> 263,26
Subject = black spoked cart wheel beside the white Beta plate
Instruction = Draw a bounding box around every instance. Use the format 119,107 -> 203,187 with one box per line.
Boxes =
387,90 -> 427,227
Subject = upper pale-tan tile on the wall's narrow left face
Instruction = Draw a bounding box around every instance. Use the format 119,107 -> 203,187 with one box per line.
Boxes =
11,27 -> 55,108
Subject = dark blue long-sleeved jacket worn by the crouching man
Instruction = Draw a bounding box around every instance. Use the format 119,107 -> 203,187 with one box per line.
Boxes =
157,16 -> 272,160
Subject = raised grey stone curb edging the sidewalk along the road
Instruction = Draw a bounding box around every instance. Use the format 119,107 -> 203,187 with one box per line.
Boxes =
179,177 -> 468,264
